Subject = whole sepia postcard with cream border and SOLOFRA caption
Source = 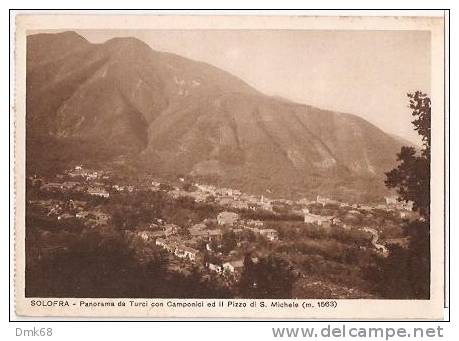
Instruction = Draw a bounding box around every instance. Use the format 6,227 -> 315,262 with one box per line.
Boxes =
11,11 -> 449,320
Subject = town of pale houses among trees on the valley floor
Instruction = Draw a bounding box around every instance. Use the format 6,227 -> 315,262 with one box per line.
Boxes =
26,165 -> 417,298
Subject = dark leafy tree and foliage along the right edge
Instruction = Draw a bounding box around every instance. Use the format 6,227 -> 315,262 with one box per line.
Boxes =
366,91 -> 431,299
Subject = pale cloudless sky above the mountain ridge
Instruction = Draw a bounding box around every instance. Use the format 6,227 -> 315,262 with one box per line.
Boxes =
48,30 -> 431,143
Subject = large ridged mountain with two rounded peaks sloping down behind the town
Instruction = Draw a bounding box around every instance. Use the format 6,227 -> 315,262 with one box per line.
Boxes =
27,32 -> 401,197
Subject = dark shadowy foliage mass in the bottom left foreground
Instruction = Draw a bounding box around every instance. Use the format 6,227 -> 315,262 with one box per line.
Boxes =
26,231 -> 232,298
